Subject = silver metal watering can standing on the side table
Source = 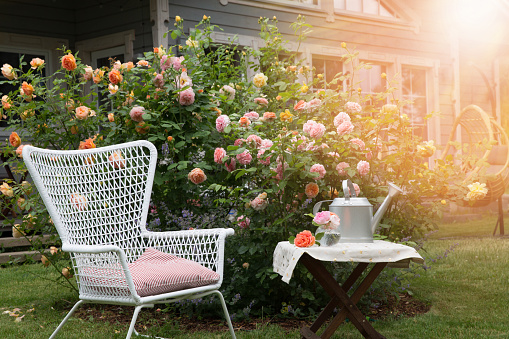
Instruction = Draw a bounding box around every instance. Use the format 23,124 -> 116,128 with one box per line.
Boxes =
313,179 -> 402,243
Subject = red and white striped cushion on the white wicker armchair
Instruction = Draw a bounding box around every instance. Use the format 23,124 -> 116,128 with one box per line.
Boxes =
129,248 -> 220,297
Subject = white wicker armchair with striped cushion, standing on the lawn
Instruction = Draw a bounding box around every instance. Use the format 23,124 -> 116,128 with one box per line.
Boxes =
23,141 -> 235,338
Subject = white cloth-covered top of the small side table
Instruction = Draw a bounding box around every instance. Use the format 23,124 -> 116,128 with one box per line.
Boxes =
273,240 -> 424,283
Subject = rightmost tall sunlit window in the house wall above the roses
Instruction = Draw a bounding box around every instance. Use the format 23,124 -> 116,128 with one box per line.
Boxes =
401,67 -> 428,140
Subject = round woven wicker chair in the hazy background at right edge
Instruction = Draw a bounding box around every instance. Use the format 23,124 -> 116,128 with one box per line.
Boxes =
441,105 -> 509,207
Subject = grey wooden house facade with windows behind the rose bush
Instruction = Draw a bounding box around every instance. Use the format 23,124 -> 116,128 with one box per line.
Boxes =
0,0 -> 509,153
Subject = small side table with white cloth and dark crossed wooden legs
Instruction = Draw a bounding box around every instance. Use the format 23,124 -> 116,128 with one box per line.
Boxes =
274,241 -> 424,339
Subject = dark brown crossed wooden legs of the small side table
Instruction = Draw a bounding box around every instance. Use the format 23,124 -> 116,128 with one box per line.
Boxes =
300,253 -> 387,339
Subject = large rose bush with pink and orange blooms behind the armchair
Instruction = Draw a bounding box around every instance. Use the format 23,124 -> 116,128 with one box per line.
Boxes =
1,16 -> 485,318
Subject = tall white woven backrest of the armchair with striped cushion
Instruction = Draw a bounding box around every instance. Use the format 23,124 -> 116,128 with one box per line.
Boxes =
23,141 -> 157,262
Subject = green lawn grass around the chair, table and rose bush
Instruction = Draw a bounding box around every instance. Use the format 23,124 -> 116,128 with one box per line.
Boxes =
0,216 -> 509,339
